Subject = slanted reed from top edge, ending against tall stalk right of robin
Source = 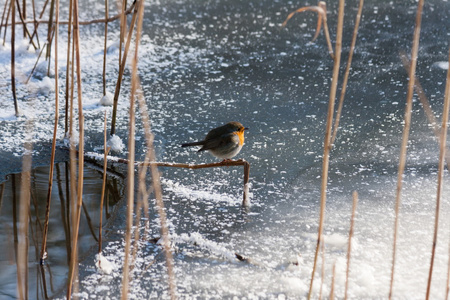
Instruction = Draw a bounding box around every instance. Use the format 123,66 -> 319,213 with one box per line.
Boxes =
331,0 -> 364,145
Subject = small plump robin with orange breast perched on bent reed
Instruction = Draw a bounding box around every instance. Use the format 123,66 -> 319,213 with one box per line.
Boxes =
181,122 -> 248,160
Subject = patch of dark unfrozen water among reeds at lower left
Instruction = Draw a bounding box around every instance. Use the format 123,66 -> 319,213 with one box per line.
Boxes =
0,163 -> 123,299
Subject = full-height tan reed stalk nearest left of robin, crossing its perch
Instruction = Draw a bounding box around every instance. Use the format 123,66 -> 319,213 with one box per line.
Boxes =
119,0 -> 144,299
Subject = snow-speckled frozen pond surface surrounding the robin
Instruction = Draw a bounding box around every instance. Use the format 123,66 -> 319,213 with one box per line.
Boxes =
0,0 -> 450,299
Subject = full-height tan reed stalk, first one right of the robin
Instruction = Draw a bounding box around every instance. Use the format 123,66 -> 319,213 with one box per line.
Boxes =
308,0 -> 345,299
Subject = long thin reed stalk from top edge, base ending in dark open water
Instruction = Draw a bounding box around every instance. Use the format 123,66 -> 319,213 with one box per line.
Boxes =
41,0 -> 59,264
